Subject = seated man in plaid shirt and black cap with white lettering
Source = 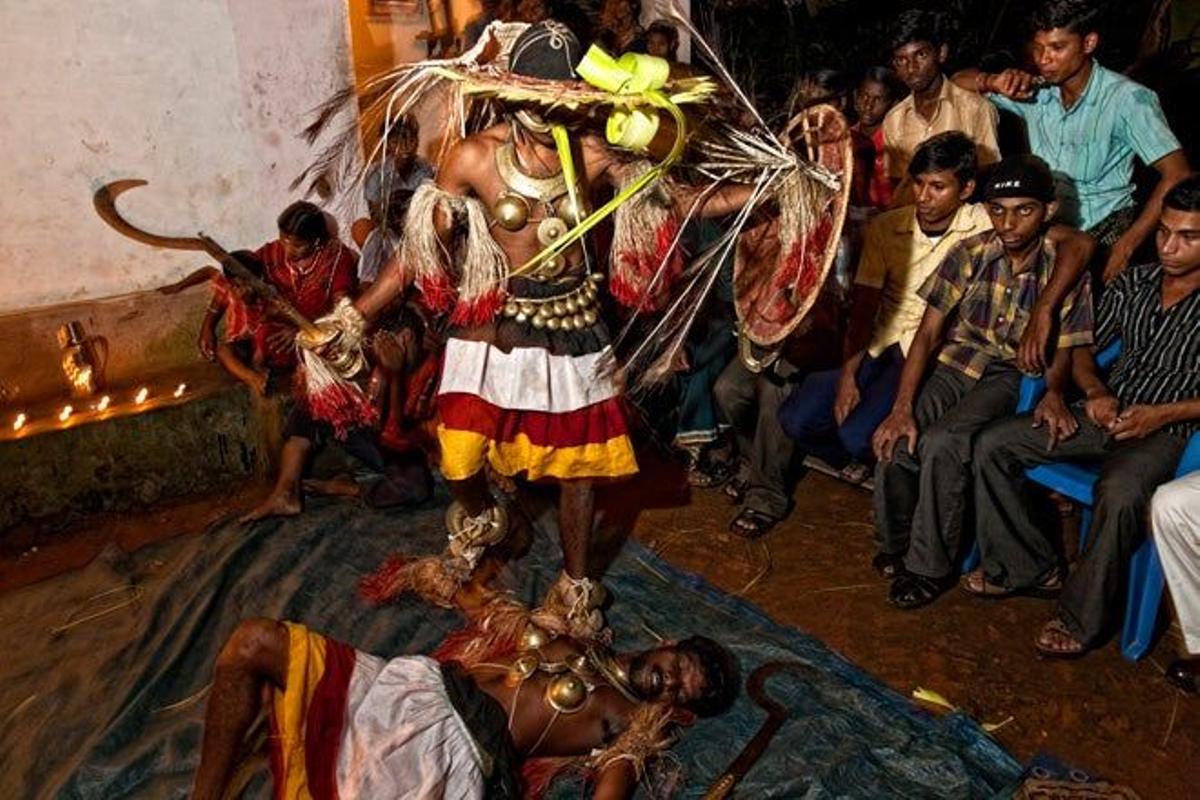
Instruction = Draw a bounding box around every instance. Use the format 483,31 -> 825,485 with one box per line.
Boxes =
874,156 -> 1092,608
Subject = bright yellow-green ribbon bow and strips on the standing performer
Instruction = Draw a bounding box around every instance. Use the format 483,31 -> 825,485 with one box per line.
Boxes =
509,44 -> 692,277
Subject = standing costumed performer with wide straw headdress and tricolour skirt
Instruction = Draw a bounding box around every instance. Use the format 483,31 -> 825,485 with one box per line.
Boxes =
296,20 -> 844,638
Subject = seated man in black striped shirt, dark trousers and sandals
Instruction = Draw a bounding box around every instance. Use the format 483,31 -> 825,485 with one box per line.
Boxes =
964,175 -> 1200,657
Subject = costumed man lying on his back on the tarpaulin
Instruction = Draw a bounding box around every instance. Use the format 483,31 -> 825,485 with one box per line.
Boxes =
192,600 -> 738,800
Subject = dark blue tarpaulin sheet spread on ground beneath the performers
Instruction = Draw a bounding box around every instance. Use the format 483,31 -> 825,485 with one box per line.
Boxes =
0,491 -> 1020,800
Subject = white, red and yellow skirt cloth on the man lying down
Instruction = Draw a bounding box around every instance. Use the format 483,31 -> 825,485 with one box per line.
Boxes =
270,622 -> 515,800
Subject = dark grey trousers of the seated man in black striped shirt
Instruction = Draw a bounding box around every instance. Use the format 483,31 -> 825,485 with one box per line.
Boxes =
974,407 -> 1187,646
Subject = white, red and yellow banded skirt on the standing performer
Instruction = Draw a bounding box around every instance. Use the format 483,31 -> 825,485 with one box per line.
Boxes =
437,338 -> 637,481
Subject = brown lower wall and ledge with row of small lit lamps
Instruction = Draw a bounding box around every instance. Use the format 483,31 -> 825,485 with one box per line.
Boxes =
0,287 -> 282,531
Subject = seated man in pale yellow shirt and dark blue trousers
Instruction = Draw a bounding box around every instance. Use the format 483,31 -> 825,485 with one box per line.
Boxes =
779,132 -> 991,482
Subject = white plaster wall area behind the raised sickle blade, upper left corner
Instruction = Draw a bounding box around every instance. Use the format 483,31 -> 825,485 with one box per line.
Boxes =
0,0 -> 350,311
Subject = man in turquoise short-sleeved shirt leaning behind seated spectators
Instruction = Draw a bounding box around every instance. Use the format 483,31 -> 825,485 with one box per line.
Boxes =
954,0 -> 1190,283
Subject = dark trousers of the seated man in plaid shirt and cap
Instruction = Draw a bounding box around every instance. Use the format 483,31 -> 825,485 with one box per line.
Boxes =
874,362 -> 1021,578
